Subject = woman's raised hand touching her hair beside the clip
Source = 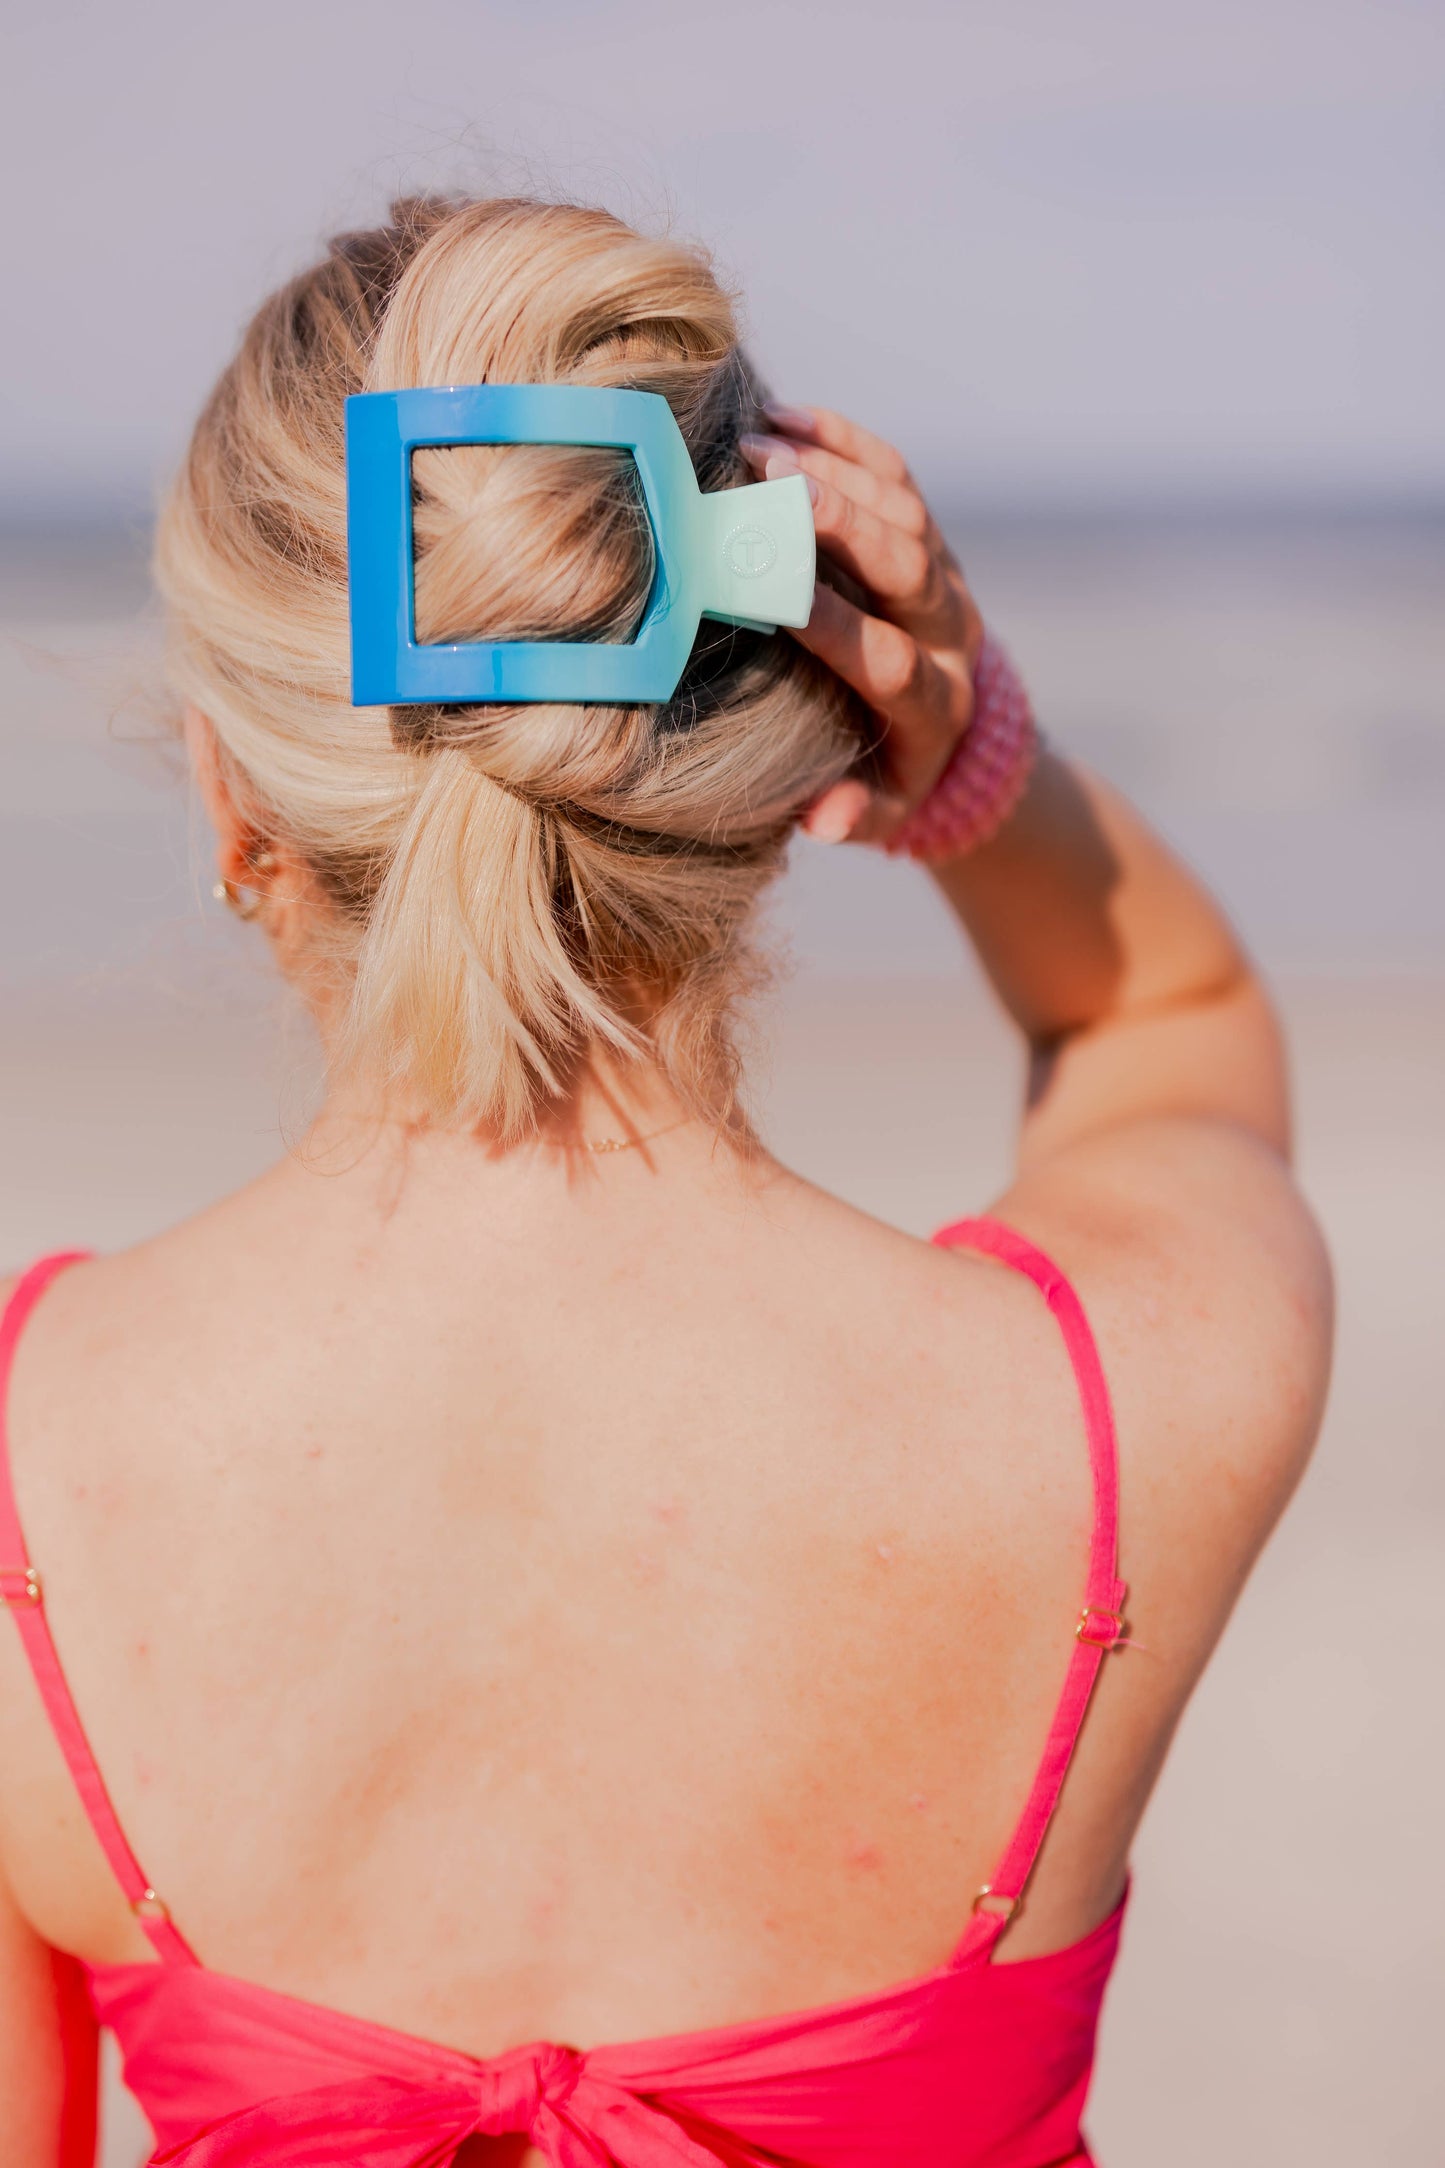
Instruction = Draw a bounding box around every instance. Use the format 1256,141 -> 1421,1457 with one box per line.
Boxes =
741,405 -> 984,843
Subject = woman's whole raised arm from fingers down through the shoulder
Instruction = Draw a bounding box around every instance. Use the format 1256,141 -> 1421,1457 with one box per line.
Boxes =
743,408 -> 1330,1560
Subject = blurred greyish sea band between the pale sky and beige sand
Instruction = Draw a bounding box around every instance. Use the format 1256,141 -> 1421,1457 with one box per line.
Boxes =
0,501 -> 1445,997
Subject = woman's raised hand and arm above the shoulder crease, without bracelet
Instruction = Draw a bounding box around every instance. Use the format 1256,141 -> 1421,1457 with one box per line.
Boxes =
745,410 -> 1289,1169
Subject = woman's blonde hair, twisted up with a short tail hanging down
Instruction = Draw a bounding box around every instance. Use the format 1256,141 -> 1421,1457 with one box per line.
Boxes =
156,197 -> 860,1136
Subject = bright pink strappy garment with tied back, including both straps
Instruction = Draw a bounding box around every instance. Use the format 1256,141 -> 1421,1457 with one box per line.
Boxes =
0,1221 -> 1124,2168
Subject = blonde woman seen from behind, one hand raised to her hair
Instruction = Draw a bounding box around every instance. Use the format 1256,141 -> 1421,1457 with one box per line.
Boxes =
0,202 -> 1330,2168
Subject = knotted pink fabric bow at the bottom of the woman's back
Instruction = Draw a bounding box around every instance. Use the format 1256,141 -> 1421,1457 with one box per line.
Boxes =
149,2047 -> 717,2168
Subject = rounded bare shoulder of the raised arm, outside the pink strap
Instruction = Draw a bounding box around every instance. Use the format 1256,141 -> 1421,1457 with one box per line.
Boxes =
983,1117 -> 1332,1600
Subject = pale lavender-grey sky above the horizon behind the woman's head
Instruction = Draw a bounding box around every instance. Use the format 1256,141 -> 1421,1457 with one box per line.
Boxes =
0,0 -> 1445,525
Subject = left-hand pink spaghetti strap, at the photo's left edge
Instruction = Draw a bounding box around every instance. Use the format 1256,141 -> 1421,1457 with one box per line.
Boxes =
0,1251 -> 197,1964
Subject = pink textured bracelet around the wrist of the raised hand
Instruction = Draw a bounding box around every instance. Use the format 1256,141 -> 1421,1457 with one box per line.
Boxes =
886,633 -> 1038,863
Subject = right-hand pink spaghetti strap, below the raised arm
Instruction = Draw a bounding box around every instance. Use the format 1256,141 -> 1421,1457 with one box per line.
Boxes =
934,1218 -> 1127,1962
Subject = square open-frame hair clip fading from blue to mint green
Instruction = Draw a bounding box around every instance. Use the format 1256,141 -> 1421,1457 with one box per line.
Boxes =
347,384 -> 815,707
